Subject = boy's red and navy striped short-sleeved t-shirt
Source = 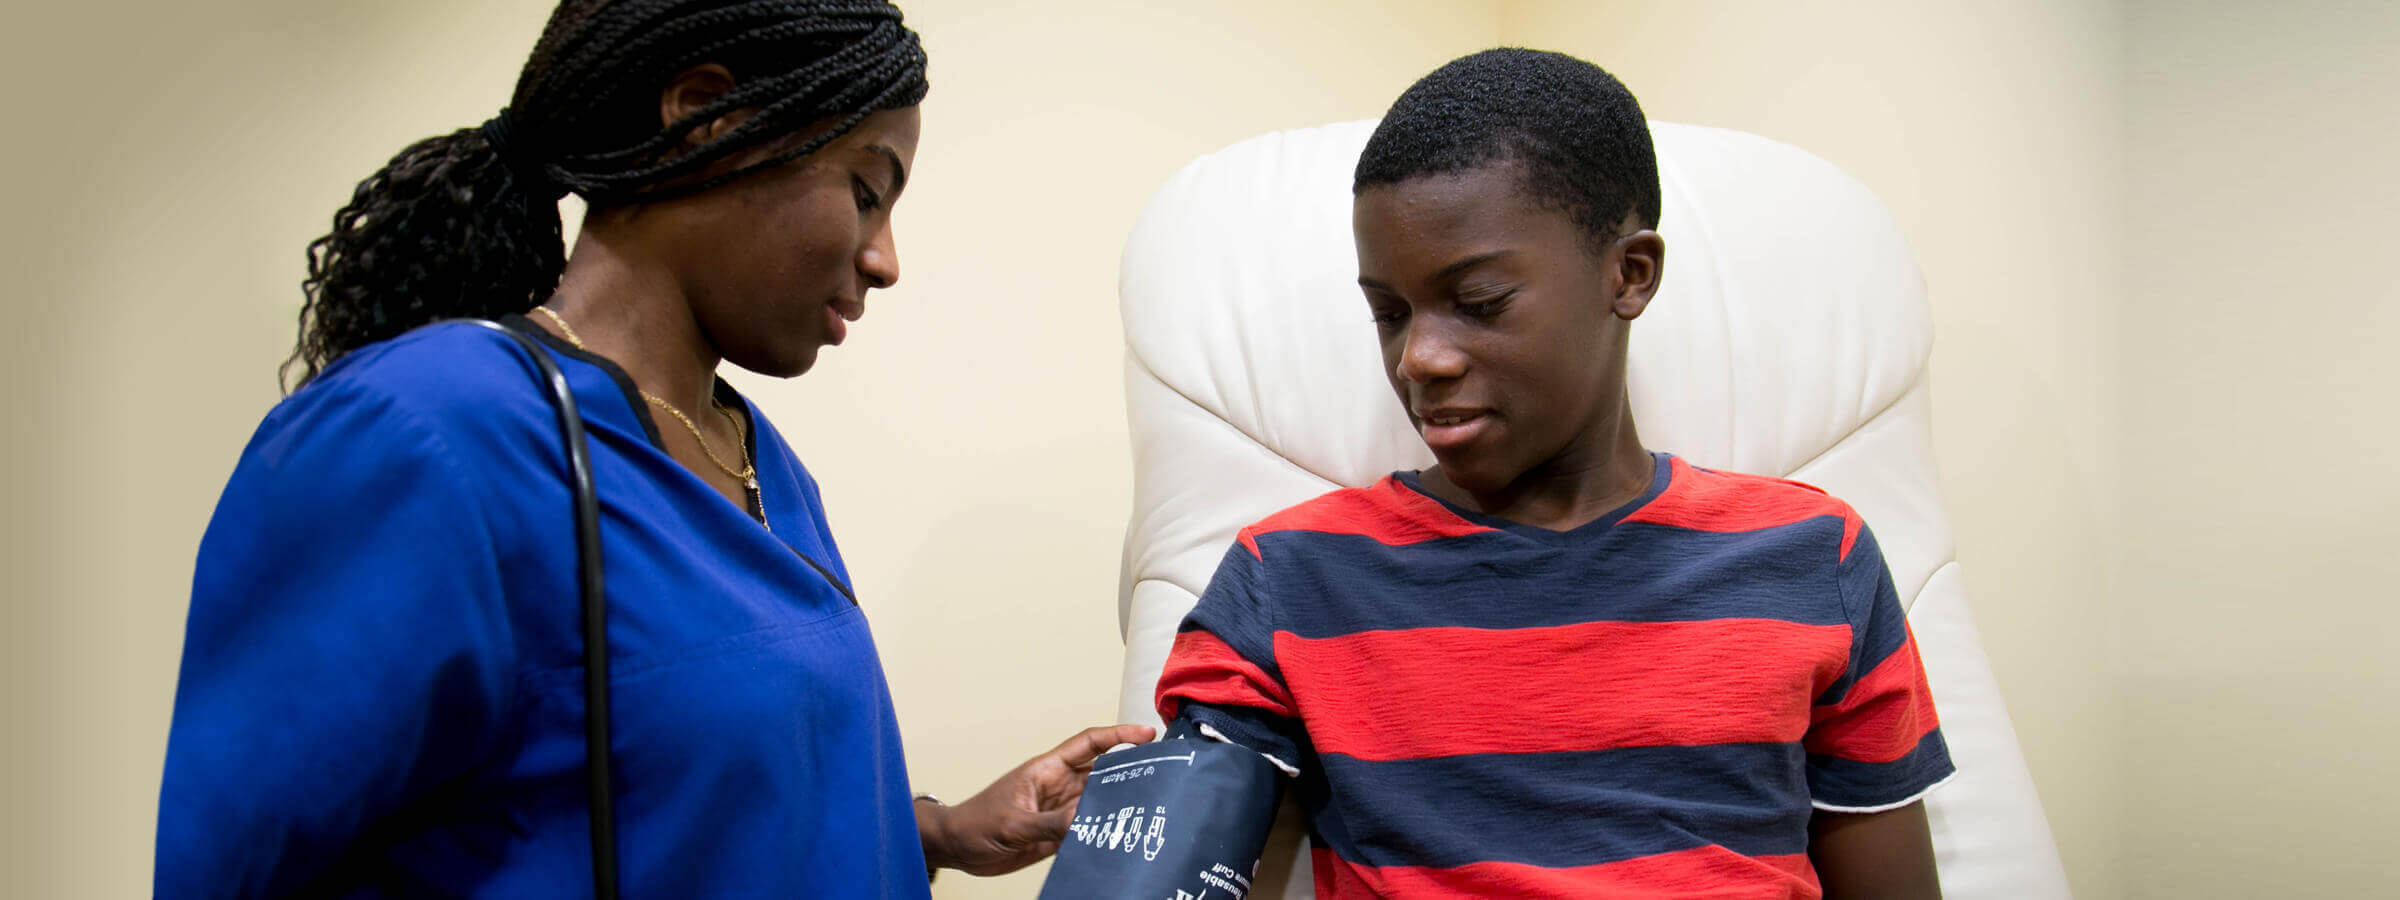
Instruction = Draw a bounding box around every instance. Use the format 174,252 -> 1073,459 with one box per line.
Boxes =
1157,454 -> 1951,898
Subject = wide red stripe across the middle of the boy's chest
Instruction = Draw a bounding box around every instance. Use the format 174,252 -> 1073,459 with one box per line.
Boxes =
1274,619 -> 1850,758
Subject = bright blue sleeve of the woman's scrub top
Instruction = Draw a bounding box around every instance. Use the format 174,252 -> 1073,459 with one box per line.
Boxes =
156,382 -> 523,898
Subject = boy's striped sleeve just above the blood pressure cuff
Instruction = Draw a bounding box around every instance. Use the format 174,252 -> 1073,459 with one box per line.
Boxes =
1157,542 -> 1310,775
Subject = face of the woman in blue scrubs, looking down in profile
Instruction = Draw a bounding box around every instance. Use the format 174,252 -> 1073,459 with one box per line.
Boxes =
674,106 -> 919,377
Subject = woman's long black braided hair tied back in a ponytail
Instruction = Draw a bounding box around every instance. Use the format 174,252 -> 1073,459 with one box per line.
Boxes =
281,0 -> 926,389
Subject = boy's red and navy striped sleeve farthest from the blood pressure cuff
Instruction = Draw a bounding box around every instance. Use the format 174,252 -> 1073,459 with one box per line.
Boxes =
1805,526 -> 1956,814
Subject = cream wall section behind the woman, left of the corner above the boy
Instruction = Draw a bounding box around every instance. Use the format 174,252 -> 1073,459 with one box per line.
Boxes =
0,0 -> 1498,898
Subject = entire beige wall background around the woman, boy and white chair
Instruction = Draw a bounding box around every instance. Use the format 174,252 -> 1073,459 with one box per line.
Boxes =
0,0 -> 2400,898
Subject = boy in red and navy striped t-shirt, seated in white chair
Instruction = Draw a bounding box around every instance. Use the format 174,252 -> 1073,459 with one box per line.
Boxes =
1157,50 -> 1951,898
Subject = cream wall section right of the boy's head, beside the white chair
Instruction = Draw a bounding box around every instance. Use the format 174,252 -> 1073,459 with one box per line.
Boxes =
1502,0 -> 2126,898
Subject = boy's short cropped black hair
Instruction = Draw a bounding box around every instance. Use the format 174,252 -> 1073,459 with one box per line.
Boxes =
1351,48 -> 1658,247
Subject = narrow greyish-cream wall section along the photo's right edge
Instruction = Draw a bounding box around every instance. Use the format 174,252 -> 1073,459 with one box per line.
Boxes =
2119,0 -> 2400,898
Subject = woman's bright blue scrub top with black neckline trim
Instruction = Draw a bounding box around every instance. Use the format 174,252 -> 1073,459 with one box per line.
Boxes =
156,319 -> 929,900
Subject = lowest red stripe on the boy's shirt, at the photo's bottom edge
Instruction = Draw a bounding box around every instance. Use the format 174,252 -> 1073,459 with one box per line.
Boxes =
1310,845 -> 1824,900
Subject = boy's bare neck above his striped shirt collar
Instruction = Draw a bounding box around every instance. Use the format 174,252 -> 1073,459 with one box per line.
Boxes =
1421,415 -> 1658,530
